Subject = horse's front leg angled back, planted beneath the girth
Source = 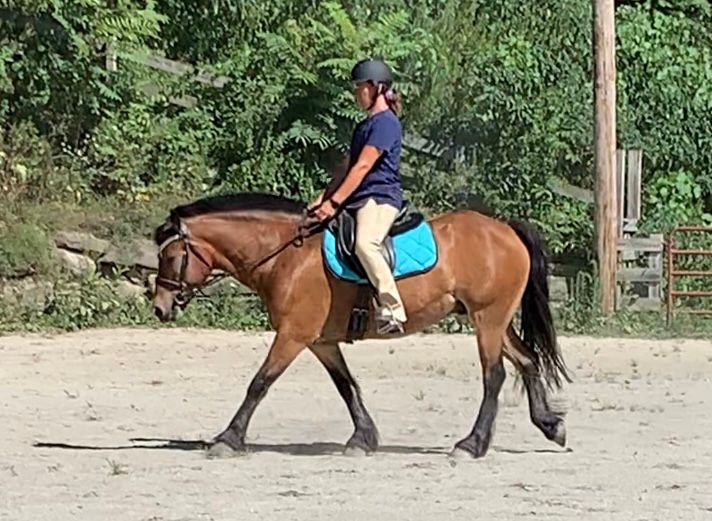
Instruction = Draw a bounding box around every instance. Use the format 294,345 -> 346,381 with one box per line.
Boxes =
310,344 -> 378,452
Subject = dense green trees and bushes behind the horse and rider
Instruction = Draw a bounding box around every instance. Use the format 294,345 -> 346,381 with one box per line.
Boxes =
0,0 -> 712,329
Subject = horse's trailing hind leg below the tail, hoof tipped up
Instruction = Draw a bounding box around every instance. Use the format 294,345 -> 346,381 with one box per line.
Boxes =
504,326 -> 566,447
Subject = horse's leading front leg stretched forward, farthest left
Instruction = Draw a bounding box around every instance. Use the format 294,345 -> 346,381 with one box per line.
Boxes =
208,333 -> 306,457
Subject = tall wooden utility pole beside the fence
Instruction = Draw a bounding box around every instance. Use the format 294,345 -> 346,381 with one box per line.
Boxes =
592,0 -> 618,315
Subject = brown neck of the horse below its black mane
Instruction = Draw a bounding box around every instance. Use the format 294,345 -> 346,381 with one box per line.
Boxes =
192,214 -> 299,290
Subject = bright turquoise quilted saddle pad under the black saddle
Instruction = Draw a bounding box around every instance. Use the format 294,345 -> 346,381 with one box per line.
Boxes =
322,220 -> 438,284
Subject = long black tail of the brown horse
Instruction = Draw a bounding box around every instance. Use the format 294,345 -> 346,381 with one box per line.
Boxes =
509,221 -> 571,388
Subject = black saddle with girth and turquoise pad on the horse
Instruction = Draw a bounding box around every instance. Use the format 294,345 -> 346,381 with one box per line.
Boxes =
323,201 -> 437,343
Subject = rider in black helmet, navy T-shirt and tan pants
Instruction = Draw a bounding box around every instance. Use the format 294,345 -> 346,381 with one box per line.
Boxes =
310,59 -> 407,333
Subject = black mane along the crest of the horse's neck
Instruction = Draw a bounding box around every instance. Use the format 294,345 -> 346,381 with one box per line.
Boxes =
153,192 -> 306,244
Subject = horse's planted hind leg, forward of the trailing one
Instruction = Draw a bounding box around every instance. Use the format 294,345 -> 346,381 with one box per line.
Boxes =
455,310 -> 507,458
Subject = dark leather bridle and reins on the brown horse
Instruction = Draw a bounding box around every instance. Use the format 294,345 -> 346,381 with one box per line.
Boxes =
156,213 -> 323,308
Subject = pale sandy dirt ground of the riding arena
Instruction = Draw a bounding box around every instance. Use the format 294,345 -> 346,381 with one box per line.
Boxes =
0,329 -> 712,521
